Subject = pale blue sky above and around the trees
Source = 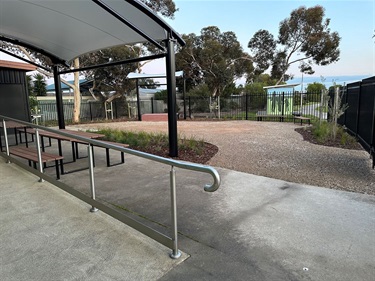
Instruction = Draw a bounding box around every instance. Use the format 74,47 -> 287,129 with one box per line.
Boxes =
143,0 -> 375,85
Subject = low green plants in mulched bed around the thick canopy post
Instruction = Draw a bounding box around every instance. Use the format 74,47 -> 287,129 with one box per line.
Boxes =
97,129 -> 204,155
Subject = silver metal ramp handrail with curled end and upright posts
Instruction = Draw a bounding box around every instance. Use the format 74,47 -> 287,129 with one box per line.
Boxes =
0,115 -> 220,258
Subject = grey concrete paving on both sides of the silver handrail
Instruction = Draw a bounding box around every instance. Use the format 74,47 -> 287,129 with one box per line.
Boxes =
0,143 -> 375,281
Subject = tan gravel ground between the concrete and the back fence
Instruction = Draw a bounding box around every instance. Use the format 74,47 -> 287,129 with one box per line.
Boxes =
72,121 -> 375,195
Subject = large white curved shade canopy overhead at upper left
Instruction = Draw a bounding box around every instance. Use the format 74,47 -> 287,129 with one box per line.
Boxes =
0,0 -> 184,62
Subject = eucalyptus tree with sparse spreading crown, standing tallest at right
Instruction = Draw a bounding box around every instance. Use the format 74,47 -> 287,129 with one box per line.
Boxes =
248,5 -> 340,84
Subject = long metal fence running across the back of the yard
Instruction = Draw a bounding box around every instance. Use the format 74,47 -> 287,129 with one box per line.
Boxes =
38,92 -> 327,121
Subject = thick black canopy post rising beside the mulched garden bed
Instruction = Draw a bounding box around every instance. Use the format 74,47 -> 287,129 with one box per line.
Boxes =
165,38 -> 178,157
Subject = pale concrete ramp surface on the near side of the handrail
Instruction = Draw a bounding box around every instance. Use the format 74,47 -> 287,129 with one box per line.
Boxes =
0,158 -> 188,280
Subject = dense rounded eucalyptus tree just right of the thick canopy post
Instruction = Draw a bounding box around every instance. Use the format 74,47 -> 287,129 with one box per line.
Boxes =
176,26 -> 253,96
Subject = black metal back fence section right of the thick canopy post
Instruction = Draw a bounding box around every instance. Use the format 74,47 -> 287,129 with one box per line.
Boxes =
184,92 -> 328,121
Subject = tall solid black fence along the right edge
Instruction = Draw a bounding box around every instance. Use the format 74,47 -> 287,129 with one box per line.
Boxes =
338,76 -> 375,159
